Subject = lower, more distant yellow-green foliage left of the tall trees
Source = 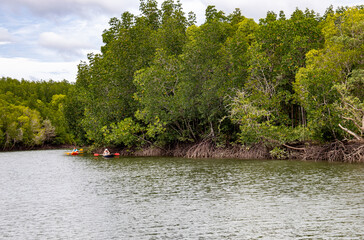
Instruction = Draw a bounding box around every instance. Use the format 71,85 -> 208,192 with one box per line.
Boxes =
0,78 -> 73,149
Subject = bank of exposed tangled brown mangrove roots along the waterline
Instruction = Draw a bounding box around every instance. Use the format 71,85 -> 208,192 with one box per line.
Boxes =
115,141 -> 364,163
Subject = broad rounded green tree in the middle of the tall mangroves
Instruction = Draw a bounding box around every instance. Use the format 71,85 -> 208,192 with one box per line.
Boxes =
134,6 -> 241,143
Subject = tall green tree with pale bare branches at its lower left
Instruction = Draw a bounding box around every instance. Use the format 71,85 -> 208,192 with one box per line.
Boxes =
230,9 -> 322,144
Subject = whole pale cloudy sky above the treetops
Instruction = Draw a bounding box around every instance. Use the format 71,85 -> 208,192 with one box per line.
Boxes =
0,0 -> 362,82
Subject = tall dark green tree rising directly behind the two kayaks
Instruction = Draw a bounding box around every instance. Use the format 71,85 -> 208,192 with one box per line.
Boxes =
76,0 -> 169,145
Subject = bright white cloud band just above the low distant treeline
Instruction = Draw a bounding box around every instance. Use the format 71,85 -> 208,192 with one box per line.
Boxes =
0,58 -> 79,82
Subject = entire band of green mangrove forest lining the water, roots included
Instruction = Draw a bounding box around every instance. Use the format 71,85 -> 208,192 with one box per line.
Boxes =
0,0 -> 364,162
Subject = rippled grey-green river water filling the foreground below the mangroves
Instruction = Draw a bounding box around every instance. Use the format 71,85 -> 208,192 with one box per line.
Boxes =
0,150 -> 364,240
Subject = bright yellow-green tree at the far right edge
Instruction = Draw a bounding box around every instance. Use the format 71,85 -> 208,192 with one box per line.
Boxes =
295,7 -> 364,140
